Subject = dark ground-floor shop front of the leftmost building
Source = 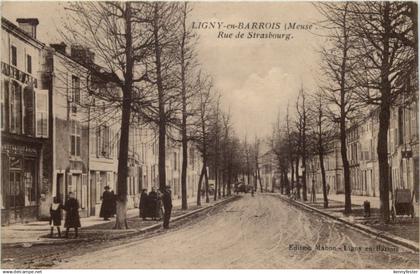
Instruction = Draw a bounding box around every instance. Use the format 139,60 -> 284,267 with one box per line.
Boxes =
1,139 -> 41,225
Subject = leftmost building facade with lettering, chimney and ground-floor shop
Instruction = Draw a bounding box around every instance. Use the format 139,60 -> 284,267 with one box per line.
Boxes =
0,18 -> 51,224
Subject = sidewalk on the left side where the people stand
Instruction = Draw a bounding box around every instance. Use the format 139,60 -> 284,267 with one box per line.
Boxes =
1,196 -> 233,247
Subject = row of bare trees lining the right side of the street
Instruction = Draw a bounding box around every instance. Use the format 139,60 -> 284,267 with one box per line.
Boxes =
272,1 -> 418,222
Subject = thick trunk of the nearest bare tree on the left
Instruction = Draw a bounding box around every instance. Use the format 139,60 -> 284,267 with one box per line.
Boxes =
114,2 -> 134,229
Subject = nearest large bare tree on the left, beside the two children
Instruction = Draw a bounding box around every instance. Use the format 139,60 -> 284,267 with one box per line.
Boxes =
62,2 -> 153,229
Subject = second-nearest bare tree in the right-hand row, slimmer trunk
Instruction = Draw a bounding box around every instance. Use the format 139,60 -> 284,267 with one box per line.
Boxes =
317,2 -> 360,214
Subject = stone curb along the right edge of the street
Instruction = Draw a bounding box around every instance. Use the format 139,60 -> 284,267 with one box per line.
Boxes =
276,195 -> 419,252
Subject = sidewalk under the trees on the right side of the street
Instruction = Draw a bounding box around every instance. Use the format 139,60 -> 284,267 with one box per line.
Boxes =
281,194 -> 419,250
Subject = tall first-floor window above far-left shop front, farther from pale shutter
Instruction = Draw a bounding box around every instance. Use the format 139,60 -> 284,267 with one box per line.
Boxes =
10,81 -> 22,134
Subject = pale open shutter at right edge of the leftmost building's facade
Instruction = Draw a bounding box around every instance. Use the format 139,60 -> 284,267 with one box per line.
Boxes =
35,89 -> 48,138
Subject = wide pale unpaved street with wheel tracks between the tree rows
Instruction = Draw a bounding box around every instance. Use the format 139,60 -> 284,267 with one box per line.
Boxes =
56,194 -> 419,268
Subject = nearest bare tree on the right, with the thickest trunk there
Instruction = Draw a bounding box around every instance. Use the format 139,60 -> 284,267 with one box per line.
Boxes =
350,2 -> 417,223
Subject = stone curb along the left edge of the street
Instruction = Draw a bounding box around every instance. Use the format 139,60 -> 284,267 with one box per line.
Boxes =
1,196 -> 240,248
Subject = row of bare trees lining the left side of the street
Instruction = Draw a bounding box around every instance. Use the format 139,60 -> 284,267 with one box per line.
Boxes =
61,1 -> 249,229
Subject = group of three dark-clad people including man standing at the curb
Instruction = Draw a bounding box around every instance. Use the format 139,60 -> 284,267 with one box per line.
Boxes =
139,186 -> 172,228
